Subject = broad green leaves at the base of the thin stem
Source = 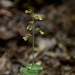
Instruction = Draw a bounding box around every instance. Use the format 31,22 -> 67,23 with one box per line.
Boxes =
20,64 -> 43,75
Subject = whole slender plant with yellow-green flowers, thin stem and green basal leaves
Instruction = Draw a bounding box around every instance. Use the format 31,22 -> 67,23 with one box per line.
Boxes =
20,9 -> 44,75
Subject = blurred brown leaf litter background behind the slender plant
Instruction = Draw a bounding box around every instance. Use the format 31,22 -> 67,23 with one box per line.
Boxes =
0,0 -> 75,75
